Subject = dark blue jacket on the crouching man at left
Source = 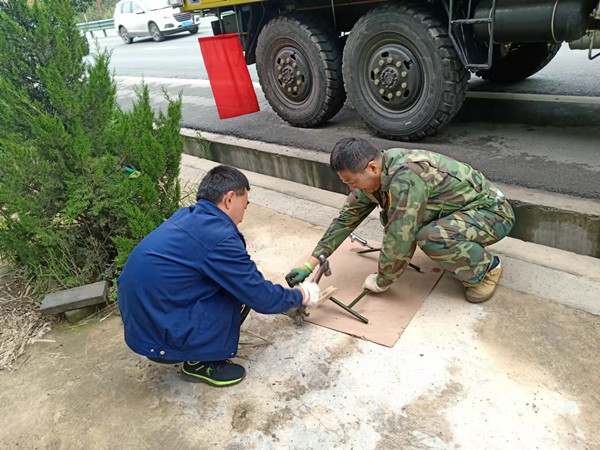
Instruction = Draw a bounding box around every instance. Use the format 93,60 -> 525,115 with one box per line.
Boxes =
118,200 -> 302,361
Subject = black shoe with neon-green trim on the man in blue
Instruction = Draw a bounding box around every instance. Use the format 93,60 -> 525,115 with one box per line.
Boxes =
181,359 -> 246,387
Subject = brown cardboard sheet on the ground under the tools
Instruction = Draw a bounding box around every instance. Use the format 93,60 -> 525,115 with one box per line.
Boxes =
292,238 -> 443,347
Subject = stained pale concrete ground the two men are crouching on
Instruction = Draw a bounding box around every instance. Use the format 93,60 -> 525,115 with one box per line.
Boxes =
0,156 -> 600,449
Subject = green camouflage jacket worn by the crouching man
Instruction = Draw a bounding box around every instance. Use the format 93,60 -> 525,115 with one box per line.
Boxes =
312,148 -> 503,286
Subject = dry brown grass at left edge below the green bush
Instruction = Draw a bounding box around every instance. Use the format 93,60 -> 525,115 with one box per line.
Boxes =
0,267 -> 56,370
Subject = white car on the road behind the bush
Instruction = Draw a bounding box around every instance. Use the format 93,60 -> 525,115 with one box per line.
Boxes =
114,0 -> 200,44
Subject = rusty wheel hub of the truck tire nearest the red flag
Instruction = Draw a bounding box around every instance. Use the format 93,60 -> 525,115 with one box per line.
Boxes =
275,47 -> 312,102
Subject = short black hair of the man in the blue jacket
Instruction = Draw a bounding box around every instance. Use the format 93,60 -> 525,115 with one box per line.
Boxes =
196,166 -> 250,205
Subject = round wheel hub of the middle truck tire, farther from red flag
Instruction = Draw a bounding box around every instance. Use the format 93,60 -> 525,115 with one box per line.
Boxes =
366,43 -> 423,111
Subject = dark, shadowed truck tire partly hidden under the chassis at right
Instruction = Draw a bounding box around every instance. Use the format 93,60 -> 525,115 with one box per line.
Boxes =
475,42 -> 561,83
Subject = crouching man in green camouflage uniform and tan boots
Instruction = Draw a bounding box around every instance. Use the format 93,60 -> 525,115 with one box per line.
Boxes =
286,138 -> 515,303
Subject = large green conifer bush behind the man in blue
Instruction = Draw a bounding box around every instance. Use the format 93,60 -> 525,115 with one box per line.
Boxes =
0,0 -> 183,288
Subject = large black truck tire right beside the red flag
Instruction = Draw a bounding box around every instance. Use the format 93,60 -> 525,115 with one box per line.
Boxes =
256,16 -> 346,127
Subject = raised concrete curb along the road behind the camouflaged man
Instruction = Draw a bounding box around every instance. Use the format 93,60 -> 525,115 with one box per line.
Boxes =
181,129 -> 600,258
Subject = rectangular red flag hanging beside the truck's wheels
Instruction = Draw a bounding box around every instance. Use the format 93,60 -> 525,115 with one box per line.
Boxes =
198,33 -> 260,119
